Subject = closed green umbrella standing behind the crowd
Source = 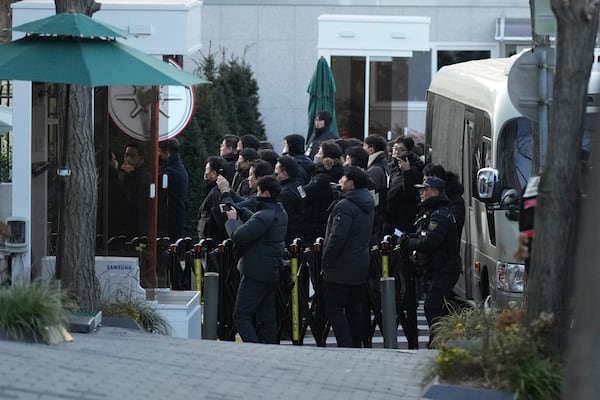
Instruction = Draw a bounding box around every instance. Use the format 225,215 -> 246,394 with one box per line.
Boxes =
306,57 -> 338,143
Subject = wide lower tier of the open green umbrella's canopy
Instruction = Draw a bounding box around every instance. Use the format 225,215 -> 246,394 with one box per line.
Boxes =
0,36 -> 207,86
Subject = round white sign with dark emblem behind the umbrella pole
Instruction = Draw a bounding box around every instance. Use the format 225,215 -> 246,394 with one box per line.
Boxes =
108,60 -> 194,141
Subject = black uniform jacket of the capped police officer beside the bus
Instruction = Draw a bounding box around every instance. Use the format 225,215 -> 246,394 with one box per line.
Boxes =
407,194 -> 461,274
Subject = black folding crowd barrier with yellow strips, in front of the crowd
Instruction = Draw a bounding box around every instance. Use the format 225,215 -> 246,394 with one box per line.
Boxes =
92,231 -> 419,349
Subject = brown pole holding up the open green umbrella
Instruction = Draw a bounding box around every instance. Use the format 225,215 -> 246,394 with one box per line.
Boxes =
146,86 -> 160,296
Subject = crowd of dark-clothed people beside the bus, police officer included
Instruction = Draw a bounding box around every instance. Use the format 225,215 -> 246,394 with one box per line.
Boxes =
198,112 -> 465,347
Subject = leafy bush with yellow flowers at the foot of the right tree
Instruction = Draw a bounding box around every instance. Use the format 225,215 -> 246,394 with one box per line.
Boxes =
433,307 -> 562,400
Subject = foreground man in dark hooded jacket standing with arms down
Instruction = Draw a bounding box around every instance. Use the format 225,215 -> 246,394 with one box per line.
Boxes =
322,166 -> 375,347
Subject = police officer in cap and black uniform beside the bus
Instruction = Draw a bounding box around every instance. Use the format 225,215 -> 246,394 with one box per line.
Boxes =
401,177 -> 461,344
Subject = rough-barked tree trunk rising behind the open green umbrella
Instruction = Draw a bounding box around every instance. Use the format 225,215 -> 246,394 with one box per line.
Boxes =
55,0 -> 100,310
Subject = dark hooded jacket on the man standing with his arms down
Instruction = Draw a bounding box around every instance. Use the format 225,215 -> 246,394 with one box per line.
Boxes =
322,188 -> 375,285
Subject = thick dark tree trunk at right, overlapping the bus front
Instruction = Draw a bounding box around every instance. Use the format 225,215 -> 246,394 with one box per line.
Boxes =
527,0 -> 598,357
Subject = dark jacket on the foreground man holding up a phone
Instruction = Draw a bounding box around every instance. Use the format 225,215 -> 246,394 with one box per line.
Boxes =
225,198 -> 288,282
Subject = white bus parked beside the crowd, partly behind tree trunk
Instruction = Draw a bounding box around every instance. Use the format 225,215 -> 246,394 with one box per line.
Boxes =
426,53 -> 600,308
